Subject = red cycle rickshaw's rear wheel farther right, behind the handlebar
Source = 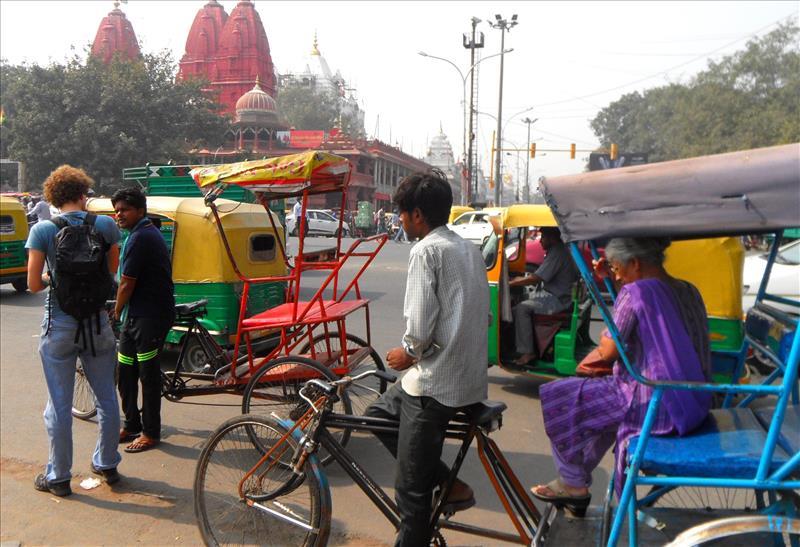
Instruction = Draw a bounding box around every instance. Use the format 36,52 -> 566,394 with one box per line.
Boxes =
300,331 -> 386,416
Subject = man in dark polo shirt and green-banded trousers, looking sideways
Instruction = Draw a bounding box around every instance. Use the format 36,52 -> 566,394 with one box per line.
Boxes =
111,188 -> 175,452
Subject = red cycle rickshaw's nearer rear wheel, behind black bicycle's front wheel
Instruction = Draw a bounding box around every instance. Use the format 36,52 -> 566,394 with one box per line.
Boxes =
242,356 -> 352,465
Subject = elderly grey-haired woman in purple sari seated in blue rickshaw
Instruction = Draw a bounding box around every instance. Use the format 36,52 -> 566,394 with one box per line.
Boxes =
531,238 -> 711,516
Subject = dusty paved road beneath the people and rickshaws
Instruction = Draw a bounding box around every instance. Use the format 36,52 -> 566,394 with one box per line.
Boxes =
0,238 -> 612,545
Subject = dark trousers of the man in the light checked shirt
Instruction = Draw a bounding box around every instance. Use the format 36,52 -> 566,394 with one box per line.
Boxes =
364,382 -> 458,547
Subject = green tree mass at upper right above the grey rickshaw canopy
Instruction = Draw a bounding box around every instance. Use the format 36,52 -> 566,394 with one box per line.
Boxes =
591,23 -> 800,161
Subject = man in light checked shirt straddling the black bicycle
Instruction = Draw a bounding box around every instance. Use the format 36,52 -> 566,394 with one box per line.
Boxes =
365,170 -> 490,546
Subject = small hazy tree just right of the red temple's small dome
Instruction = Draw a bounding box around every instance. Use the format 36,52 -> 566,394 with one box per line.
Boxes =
277,82 -> 364,137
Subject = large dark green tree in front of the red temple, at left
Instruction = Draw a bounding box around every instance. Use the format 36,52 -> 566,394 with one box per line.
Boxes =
0,52 -> 228,193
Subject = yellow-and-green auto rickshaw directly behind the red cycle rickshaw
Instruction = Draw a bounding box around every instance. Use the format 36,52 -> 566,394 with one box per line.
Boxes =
88,196 -> 287,368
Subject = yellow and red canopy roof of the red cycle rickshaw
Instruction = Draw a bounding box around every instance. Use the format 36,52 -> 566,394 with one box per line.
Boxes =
190,151 -> 350,198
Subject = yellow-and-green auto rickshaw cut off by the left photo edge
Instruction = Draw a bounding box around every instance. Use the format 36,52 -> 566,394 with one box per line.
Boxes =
0,196 -> 28,292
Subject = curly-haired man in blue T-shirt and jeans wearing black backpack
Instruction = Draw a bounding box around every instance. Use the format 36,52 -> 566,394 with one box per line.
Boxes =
25,165 -> 121,496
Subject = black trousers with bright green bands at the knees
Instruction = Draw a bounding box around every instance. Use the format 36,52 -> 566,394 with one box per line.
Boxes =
117,315 -> 173,440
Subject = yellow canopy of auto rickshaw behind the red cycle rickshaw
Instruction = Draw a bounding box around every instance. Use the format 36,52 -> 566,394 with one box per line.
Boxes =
87,196 -> 286,283
